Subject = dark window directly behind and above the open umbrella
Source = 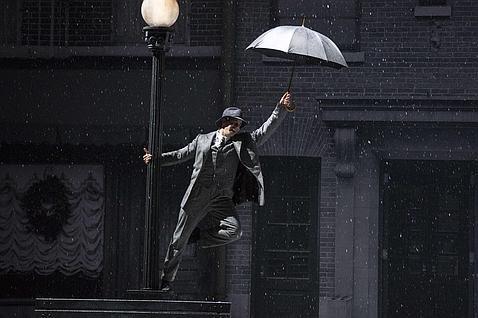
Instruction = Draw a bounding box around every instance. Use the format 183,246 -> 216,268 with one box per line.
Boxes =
271,0 -> 360,50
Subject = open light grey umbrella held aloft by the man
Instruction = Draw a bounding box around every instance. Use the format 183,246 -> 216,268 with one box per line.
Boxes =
246,24 -> 348,90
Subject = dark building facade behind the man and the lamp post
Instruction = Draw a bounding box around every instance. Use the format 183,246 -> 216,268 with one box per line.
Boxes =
0,0 -> 478,318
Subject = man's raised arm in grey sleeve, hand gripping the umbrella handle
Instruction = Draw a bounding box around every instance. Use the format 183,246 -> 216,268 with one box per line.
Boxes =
251,92 -> 292,146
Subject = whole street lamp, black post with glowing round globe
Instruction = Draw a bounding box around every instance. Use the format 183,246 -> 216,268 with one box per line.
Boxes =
141,0 -> 179,290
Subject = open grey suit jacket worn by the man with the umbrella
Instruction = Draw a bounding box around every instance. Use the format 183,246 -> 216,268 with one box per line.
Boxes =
161,104 -> 287,209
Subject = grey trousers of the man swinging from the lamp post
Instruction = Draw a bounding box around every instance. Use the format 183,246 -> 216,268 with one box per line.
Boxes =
161,186 -> 242,281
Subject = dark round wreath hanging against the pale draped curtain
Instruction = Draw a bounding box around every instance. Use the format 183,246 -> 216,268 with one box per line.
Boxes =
22,176 -> 71,242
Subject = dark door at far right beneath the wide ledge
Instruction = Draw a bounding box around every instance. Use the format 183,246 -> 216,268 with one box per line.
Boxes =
382,161 -> 471,318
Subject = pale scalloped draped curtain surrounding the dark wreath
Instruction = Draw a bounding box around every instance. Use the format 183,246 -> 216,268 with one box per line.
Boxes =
0,165 -> 105,278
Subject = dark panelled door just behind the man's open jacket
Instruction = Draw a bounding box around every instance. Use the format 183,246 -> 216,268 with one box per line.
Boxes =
253,157 -> 320,318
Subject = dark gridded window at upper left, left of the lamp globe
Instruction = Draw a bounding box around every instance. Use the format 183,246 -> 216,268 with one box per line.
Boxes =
20,0 -> 113,46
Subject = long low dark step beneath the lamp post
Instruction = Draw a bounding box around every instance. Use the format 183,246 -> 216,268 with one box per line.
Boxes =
35,298 -> 231,318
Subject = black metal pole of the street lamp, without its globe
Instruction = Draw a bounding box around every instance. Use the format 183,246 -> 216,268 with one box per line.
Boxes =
142,27 -> 172,290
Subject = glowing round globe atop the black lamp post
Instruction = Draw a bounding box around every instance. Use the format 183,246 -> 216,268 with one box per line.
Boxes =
141,0 -> 179,28
